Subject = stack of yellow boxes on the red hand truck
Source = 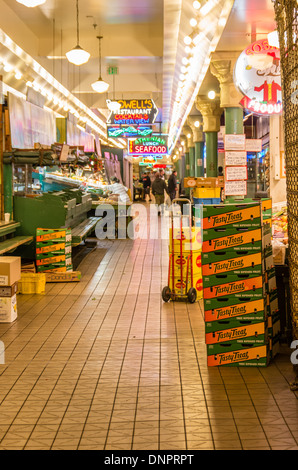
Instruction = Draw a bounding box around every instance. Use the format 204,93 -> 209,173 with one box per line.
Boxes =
169,227 -> 203,298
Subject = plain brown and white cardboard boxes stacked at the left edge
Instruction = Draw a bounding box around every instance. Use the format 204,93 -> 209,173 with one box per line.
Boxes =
0,256 -> 21,323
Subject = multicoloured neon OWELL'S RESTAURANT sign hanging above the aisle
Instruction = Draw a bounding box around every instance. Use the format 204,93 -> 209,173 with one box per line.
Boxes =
107,99 -> 158,126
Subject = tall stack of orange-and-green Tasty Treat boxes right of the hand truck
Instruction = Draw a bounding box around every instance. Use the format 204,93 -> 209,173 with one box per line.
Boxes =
202,200 -> 280,366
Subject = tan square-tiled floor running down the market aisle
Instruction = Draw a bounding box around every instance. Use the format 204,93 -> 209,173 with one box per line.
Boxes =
0,207 -> 298,450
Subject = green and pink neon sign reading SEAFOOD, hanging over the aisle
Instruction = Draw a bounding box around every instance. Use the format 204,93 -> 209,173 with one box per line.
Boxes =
128,135 -> 168,156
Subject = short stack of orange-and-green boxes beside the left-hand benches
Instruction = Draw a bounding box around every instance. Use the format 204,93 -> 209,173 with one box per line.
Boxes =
36,228 -> 73,273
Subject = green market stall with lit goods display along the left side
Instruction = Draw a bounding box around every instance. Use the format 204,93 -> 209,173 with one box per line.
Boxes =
0,144 -> 131,259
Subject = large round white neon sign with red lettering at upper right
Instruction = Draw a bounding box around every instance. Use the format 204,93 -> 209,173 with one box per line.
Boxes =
234,39 -> 283,116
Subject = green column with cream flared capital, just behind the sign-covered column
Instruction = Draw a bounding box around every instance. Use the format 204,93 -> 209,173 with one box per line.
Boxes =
196,96 -> 222,178
